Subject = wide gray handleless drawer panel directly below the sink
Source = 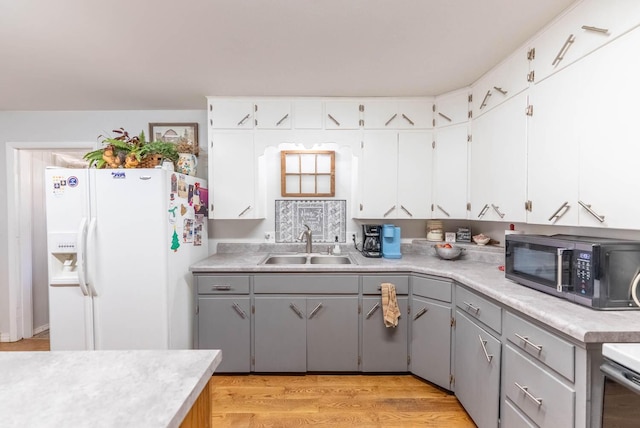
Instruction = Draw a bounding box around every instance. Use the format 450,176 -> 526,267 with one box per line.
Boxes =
253,275 -> 358,294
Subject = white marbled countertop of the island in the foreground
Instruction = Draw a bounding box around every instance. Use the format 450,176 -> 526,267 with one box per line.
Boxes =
0,350 -> 222,428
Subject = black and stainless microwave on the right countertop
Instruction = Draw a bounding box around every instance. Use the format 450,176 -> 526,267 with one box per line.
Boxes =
505,234 -> 640,310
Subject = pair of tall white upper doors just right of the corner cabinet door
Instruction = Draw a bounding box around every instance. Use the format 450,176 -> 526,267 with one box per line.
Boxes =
470,92 -> 527,222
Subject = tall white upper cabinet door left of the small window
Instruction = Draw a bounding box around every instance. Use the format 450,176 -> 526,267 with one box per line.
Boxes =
209,132 -> 259,220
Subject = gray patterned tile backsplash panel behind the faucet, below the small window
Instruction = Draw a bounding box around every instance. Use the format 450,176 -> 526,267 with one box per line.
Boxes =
275,199 -> 347,243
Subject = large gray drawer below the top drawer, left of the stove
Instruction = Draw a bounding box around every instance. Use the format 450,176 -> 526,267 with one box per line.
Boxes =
503,345 -> 575,427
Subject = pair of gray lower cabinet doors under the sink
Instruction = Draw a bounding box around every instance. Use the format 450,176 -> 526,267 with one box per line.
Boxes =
254,295 -> 358,372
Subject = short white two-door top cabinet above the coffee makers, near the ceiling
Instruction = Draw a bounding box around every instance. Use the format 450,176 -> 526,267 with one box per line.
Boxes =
361,98 -> 433,129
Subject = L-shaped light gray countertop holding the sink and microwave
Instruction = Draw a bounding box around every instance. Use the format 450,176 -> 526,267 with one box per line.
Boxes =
191,241 -> 640,344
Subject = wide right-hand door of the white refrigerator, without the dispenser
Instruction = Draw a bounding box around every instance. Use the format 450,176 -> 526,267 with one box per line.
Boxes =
87,169 -> 171,349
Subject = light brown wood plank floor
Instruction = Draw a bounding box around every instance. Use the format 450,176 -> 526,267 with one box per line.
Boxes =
0,337 -> 475,428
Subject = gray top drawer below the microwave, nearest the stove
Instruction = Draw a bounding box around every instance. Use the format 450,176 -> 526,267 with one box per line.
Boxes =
504,312 -> 575,382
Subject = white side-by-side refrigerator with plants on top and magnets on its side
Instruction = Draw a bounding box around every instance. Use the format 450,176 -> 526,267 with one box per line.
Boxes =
45,168 -> 208,351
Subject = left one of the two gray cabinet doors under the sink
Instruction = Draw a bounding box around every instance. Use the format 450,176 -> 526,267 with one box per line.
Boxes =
253,296 -> 307,372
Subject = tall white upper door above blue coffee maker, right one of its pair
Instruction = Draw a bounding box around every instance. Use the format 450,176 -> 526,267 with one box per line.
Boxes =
395,131 -> 433,219
